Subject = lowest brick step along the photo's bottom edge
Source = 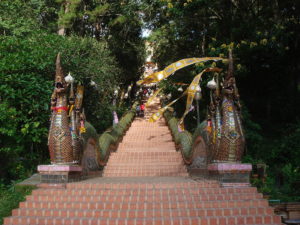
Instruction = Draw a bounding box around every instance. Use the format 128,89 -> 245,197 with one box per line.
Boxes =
4,215 -> 281,225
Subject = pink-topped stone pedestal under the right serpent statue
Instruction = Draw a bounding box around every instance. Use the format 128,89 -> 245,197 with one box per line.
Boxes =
207,163 -> 252,187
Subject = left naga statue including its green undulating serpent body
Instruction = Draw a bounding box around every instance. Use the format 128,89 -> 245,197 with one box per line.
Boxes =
48,54 -> 135,175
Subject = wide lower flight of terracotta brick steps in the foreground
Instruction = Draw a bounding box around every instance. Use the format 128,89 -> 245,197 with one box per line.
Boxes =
4,177 -> 280,225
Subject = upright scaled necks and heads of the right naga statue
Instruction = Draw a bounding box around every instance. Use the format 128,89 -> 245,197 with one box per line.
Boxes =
191,51 -> 245,163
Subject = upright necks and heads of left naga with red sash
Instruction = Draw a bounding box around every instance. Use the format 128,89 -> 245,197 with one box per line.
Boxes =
48,54 -> 83,164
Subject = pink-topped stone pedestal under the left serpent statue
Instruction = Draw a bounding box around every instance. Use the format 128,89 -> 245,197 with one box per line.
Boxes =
38,165 -> 82,184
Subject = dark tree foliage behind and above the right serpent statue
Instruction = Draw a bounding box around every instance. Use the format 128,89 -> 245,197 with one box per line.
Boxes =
144,0 -> 300,198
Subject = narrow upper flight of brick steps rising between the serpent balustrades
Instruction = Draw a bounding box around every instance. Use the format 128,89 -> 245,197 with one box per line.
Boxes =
103,99 -> 188,177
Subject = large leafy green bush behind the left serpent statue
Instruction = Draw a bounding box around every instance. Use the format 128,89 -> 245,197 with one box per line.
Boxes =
0,31 -> 120,183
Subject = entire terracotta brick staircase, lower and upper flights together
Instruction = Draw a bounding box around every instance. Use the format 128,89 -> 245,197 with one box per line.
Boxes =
4,97 -> 281,225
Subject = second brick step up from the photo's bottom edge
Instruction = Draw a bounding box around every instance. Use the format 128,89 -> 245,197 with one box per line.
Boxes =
12,207 -> 273,219
